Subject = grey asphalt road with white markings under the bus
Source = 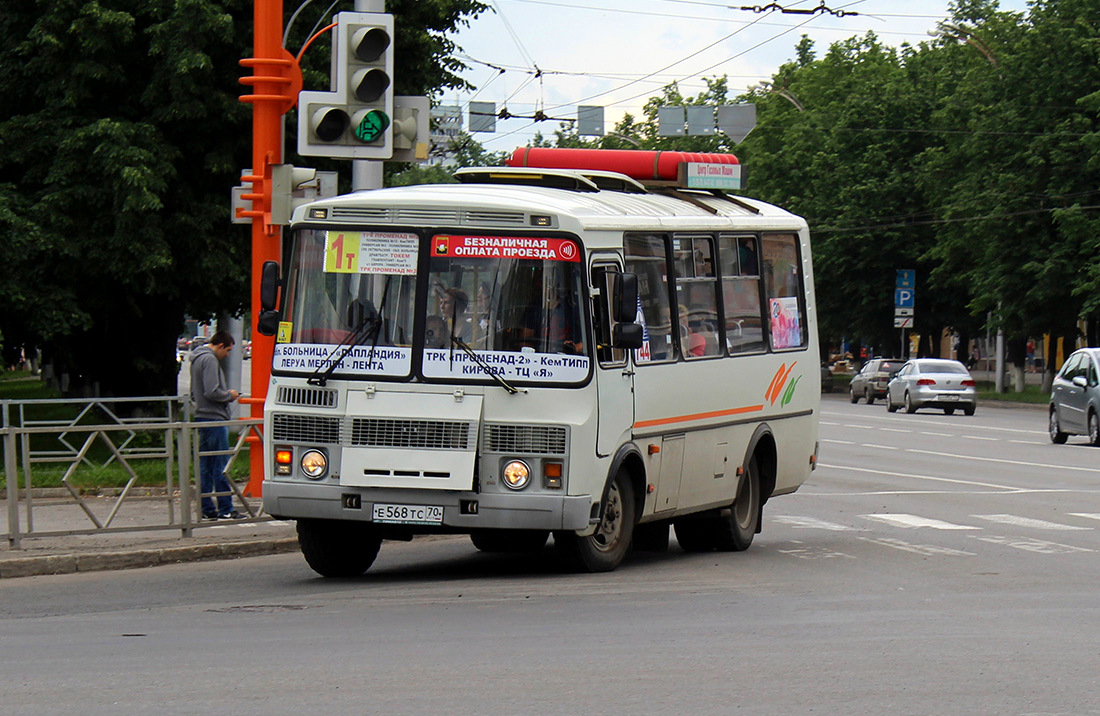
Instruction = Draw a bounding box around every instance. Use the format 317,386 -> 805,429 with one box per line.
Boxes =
0,396 -> 1100,716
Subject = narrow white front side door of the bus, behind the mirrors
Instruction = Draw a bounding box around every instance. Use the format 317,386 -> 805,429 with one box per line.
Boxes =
592,260 -> 634,456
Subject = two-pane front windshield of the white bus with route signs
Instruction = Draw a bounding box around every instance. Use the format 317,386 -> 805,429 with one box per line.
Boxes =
273,230 -> 590,384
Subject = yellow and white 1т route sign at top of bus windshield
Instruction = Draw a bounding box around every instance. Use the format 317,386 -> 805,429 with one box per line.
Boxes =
325,231 -> 419,276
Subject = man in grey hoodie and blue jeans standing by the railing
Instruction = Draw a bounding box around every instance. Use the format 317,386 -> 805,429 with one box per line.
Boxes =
191,331 -> 244,519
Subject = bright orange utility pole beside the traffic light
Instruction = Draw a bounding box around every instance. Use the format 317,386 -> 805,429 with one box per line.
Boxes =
239,0 -> 301,497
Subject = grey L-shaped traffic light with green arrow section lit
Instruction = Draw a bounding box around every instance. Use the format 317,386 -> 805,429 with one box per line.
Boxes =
298,12 -> 394,159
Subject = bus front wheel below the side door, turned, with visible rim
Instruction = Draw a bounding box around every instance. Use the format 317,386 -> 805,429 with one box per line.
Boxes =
553,471 -> 635,572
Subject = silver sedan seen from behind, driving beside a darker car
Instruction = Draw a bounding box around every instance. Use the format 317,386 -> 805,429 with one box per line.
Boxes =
887,359 -> 978,415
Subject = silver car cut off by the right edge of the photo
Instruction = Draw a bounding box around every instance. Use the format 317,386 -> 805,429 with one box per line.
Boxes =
1049,348 -> 1100,445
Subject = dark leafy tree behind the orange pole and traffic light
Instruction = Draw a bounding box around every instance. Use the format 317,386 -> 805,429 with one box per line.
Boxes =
0,0 -> 486,395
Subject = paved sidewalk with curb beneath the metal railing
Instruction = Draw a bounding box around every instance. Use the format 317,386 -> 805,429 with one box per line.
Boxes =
0,496 -> 298,580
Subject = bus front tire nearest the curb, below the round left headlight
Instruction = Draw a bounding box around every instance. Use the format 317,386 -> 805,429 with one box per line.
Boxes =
298,519 -> 382,577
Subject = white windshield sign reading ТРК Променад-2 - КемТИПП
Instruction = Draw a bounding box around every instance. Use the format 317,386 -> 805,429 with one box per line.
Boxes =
424,349 -> 589,383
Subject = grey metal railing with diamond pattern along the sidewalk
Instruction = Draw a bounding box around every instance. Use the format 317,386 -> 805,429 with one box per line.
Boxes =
0,397 -> 271,550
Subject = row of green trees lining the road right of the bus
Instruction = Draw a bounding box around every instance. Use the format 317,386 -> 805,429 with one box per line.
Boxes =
523,0 -> 1100,352
